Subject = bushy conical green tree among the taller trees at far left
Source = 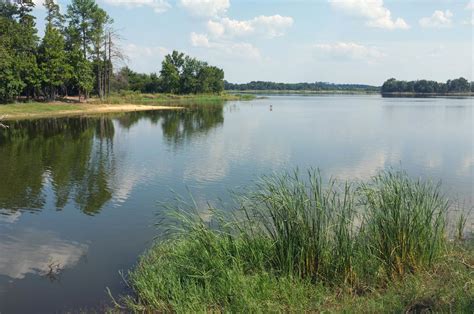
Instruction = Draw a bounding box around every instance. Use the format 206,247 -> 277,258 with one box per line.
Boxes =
39,22 -> 71,100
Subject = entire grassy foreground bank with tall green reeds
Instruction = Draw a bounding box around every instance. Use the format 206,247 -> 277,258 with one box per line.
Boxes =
117,170 -> 474,313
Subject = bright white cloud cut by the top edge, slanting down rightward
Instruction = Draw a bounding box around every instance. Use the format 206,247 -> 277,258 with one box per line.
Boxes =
328,0 -> 410,30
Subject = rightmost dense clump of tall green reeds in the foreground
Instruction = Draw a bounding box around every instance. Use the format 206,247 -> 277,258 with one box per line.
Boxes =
361,172 -> 449,276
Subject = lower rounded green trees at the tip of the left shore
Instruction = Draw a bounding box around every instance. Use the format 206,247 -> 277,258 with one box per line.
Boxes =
112,51 -> 224,94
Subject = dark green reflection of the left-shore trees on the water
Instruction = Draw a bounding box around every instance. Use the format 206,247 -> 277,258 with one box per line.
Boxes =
0,106 -> 224,219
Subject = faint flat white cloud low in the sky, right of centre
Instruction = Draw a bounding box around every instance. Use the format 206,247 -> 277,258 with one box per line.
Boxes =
313,42 -> 385,63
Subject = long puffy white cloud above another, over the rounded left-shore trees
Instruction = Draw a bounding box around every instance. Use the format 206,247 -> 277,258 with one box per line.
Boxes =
207,14 -> 293,38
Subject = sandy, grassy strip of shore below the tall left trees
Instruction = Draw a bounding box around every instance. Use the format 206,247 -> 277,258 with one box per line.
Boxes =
0,102 -> 183,121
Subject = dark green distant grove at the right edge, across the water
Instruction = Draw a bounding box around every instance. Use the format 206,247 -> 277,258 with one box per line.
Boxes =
382,77 -> 474,95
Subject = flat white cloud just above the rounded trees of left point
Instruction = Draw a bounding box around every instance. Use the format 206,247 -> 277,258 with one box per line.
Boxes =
191,32 -> 260,59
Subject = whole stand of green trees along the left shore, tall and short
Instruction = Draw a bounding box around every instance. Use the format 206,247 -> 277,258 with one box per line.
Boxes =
0,0 -> 224,103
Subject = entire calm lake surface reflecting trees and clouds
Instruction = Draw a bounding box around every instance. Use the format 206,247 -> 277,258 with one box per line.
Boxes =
0,96 -> 474,313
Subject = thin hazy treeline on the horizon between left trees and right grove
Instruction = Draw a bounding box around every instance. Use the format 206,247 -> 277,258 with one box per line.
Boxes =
225,81 -> 380,92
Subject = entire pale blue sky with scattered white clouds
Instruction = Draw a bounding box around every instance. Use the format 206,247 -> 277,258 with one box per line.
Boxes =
31,0 -> 474,85
